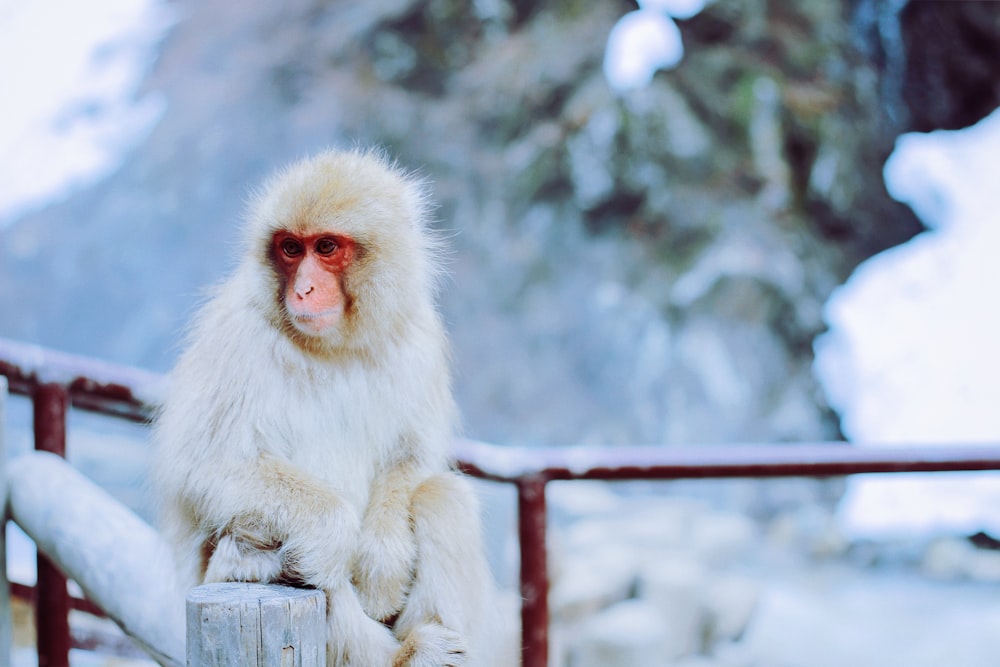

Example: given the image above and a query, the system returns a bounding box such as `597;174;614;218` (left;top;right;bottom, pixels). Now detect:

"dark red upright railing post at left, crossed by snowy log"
32;383;70;667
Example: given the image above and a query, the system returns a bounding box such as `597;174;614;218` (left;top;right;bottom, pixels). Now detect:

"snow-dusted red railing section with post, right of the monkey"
457;441;1000;667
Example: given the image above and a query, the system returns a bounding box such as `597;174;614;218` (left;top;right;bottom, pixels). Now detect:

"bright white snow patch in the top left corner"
0;0;171;227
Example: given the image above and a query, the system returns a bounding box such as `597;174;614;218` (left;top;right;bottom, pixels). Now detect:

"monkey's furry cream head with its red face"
242;151;436;354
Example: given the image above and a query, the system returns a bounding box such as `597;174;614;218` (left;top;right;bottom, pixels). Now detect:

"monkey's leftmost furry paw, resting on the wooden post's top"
205;521;282;584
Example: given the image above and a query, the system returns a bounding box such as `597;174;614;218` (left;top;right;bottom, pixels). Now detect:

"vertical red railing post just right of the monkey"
517;475;549;667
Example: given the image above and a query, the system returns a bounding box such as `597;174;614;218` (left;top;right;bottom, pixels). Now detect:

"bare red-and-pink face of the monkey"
271;231;355;336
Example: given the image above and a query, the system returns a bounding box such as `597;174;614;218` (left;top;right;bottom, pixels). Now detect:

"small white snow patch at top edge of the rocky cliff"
604;0;705;93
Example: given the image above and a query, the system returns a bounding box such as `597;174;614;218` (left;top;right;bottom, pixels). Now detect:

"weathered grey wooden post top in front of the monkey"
187;583;327;667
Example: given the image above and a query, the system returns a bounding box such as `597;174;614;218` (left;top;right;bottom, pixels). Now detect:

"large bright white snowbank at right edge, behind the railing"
815;104;1000;538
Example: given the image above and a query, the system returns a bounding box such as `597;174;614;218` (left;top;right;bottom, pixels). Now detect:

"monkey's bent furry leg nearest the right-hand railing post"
393;473;497;667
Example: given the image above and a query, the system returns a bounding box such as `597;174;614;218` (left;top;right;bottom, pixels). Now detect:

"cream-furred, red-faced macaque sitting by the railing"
154;151;511;667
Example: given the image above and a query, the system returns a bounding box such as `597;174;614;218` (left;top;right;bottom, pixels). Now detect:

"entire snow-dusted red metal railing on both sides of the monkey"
0;339;1000;667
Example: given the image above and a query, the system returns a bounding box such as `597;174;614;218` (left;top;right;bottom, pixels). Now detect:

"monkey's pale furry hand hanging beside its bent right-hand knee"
353;494;417;621
